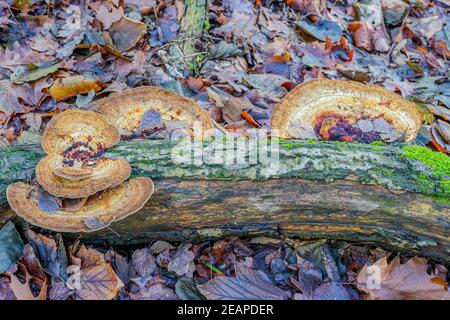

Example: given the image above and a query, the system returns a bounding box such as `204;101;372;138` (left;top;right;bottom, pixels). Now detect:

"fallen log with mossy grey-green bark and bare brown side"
0;140;450;264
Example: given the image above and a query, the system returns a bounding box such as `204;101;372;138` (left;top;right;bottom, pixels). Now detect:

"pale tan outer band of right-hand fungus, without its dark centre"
271;79;422;142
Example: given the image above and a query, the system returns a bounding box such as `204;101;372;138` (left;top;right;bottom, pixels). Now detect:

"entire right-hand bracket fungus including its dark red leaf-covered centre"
271;79;422;143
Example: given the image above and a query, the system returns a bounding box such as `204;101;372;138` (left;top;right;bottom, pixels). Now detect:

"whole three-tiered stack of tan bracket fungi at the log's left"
7;110;153;232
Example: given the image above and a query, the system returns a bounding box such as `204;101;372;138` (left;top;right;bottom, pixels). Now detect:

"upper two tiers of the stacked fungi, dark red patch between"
36;110;131;198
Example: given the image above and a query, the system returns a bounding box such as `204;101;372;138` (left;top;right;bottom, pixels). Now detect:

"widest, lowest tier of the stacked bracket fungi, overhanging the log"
6;177;154;232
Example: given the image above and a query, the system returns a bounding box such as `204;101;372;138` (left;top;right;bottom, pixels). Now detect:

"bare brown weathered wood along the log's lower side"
0;179;450;264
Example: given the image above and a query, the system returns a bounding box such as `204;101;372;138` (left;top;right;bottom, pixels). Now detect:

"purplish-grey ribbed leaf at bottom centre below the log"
198;262;291;300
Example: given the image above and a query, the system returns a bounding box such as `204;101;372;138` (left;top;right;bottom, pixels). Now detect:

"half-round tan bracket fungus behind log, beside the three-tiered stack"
95;86;213;138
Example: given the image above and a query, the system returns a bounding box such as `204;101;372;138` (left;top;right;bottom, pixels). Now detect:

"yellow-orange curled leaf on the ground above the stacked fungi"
50;75;105;100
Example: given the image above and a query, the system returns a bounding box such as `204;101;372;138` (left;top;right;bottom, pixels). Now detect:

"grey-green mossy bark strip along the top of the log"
0;139;450;204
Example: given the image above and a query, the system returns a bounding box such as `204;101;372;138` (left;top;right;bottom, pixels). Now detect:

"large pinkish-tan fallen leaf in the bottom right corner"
357;256;450;300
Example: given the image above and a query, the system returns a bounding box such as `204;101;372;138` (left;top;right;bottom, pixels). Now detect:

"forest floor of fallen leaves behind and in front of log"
0;0;450;300
